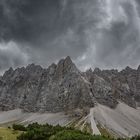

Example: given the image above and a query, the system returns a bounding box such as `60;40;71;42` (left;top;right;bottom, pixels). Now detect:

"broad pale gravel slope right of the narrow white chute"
93;103;140;137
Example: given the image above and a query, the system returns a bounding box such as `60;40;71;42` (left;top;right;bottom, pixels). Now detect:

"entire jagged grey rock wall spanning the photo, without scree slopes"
0;57;140;112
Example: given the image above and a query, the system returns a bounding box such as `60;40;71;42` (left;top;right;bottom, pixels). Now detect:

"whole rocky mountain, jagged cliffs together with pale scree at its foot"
0;57;140;136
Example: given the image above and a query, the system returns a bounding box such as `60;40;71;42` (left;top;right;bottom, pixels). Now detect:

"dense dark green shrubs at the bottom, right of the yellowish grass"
15;123;108;140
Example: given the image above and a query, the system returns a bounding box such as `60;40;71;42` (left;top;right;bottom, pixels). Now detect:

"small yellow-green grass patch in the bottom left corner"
0;128;21;140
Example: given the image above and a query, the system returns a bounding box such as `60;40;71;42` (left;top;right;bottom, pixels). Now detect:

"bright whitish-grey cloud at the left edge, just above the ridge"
0;41;29;73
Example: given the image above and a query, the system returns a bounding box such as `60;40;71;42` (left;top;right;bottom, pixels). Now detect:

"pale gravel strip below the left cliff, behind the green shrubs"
0;109;70;126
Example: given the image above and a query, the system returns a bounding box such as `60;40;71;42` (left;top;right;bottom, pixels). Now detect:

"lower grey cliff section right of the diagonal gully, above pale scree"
86;67;140;108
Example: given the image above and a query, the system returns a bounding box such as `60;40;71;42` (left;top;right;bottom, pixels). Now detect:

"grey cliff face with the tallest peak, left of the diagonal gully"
0;57;94;112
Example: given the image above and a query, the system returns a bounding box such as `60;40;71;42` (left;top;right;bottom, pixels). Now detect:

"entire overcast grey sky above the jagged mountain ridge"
0;0;140;71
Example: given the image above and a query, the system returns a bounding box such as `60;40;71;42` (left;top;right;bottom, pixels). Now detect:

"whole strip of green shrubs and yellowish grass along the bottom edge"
0;123;140;140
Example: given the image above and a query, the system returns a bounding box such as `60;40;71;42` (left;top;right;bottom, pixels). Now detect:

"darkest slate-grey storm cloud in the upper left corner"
1;0;61;42
